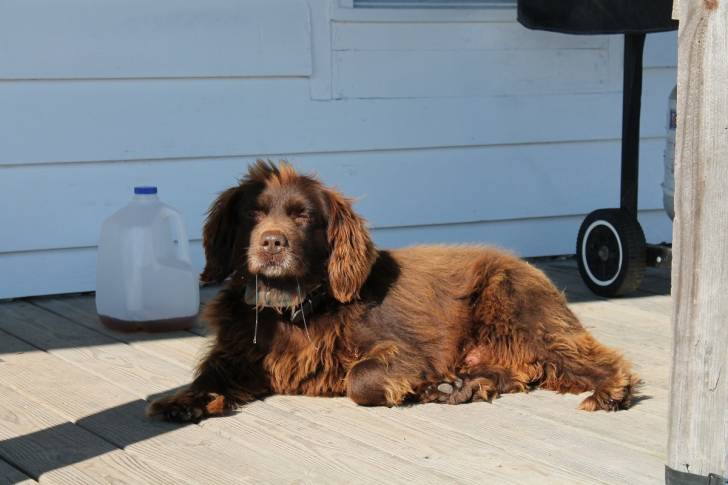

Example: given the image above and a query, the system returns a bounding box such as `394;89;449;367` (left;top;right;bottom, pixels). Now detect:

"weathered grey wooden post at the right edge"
665;0;728;485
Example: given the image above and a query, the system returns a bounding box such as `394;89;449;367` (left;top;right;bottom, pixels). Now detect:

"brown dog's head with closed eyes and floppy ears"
201;161;376;302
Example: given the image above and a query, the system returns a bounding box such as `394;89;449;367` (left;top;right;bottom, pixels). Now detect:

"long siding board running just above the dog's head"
0;74;674;165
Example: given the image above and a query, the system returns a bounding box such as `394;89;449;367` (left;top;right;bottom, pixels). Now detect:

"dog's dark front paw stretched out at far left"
147;390;225;423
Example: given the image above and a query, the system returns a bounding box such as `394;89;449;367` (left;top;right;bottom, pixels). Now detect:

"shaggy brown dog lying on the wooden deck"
148;162;638;421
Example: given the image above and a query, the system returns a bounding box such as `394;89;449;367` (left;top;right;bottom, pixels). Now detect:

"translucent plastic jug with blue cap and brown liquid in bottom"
96;183;200;332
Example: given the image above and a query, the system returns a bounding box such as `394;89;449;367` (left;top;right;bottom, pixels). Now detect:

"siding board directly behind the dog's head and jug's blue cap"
0;139;664;252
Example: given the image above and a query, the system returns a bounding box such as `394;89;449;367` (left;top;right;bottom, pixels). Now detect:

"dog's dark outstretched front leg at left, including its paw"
147;352;267;422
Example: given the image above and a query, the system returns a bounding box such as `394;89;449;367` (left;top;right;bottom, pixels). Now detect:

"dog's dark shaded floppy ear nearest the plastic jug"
200;184;245;283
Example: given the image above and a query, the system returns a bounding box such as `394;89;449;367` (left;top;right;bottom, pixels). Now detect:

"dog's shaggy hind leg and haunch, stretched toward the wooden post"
465;265;639;411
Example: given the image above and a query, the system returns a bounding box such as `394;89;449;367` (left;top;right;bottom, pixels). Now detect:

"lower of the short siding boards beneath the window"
334;49;610;98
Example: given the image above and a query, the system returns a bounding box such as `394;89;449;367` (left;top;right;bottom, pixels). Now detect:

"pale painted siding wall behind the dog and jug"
0;0;675;298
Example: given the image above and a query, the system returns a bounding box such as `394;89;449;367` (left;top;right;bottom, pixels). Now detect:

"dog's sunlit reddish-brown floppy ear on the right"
325;189;377;303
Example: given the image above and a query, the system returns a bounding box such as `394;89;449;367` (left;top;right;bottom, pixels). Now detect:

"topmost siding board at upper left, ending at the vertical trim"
0;0;311;79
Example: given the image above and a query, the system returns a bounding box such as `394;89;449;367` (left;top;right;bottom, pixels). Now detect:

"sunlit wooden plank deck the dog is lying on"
0;260;671;484
